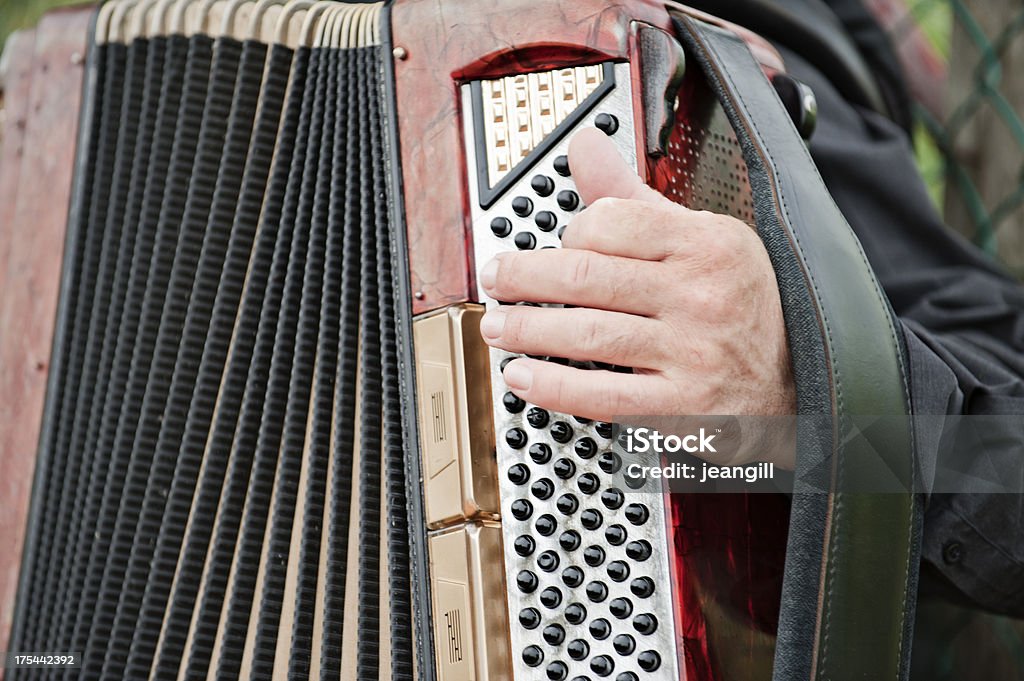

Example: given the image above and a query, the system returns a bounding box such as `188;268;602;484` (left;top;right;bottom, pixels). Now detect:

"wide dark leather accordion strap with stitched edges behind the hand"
676;13;921;681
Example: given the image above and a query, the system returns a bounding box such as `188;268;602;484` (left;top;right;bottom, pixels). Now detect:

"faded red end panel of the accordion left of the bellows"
0;8;92;663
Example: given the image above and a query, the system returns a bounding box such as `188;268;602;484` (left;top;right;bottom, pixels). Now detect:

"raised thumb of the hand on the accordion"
568;128;667;205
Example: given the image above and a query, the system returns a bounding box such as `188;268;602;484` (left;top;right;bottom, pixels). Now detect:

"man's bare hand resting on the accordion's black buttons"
480;129;796;420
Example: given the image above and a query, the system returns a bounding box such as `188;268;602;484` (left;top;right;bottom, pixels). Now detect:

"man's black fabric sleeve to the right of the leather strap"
782;49;1024;615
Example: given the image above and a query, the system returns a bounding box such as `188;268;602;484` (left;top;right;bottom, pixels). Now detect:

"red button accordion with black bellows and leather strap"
8;0;920;681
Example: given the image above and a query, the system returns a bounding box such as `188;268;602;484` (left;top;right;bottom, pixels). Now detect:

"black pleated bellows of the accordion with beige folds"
9;6;413;681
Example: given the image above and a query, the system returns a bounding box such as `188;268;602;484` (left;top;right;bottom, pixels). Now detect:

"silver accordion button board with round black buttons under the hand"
448;62;680;681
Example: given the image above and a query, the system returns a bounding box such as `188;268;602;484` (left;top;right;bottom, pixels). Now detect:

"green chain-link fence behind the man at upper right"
879;0;1024;279
